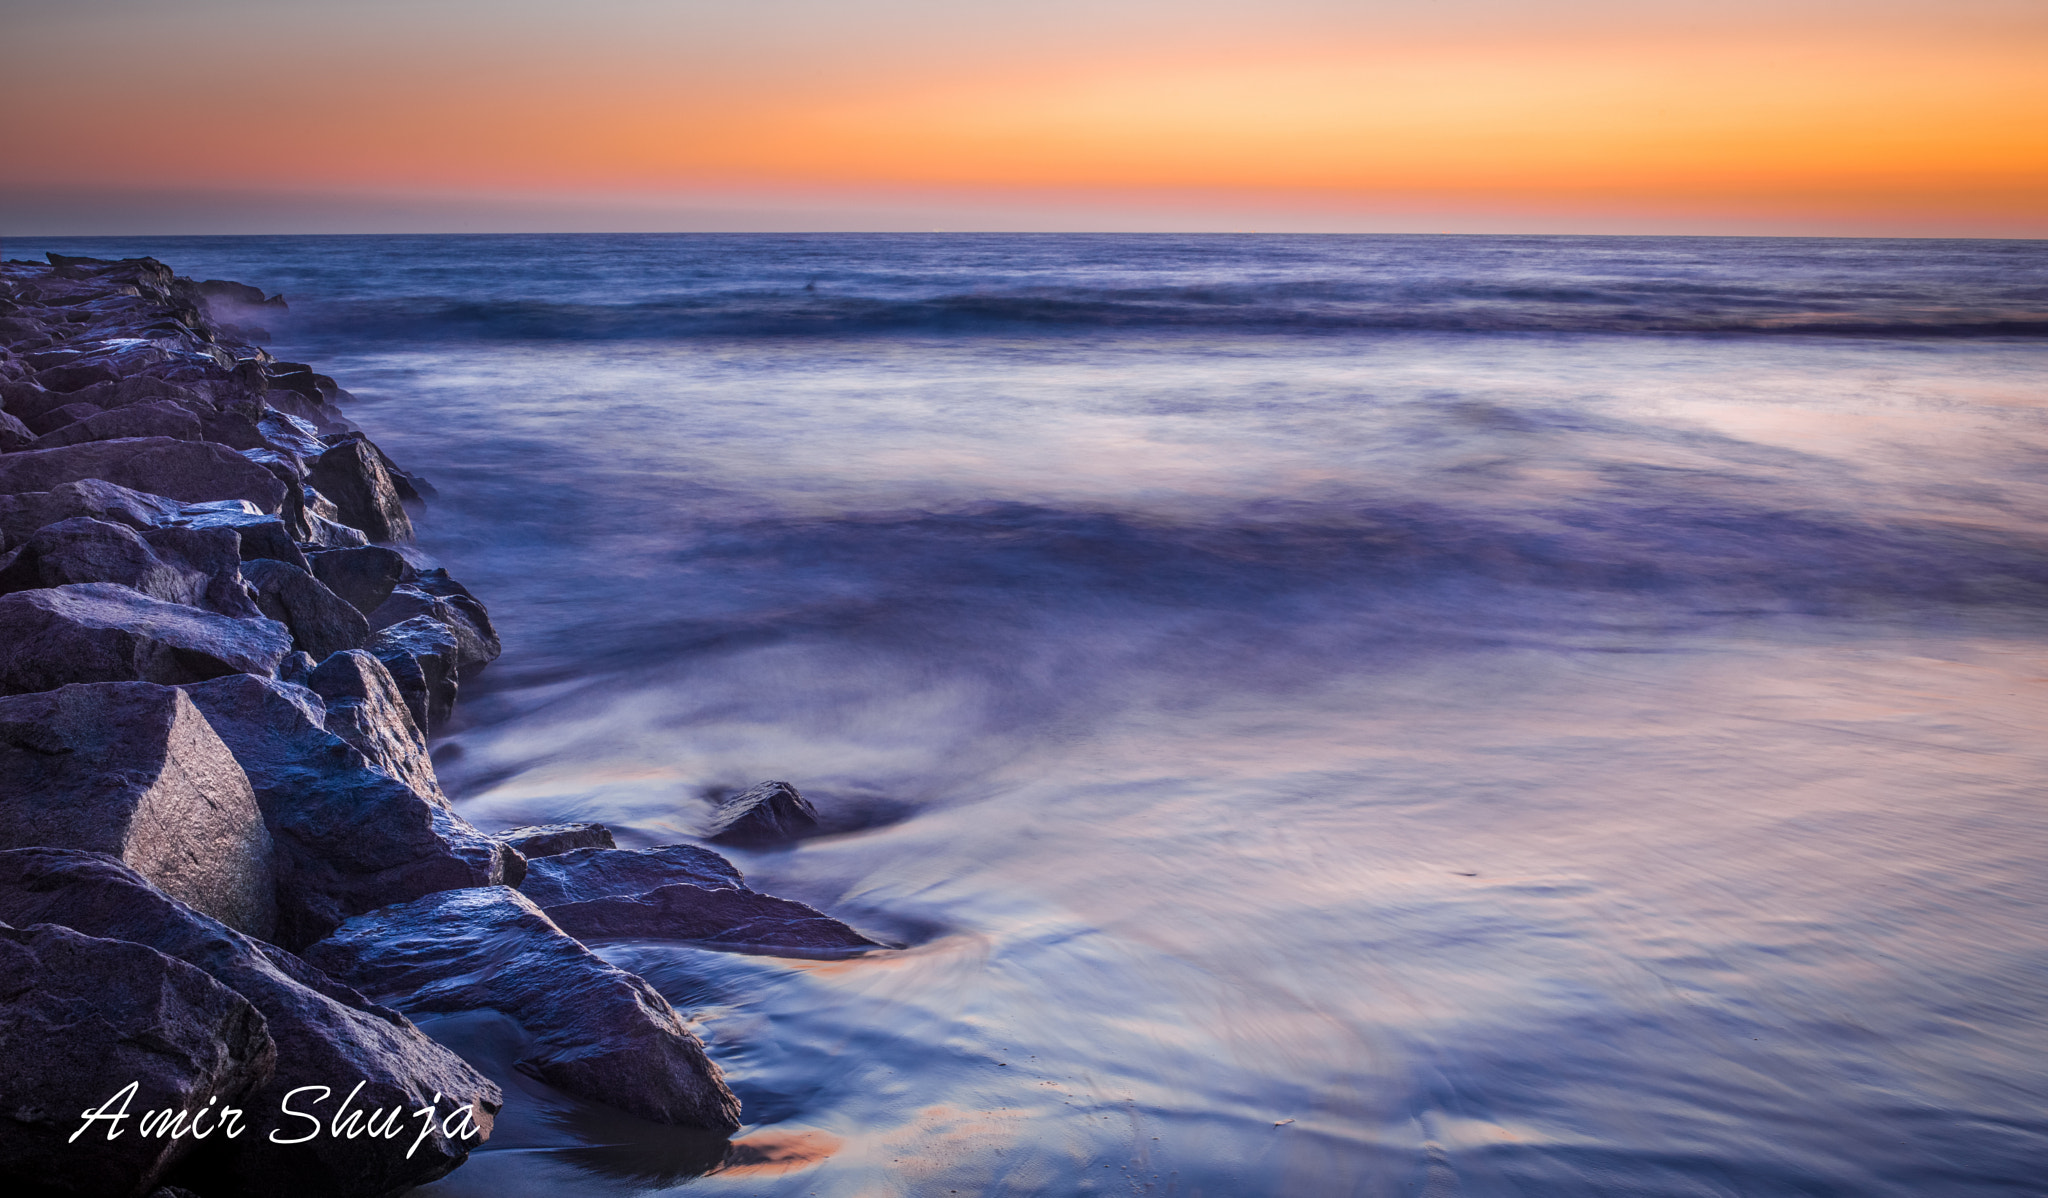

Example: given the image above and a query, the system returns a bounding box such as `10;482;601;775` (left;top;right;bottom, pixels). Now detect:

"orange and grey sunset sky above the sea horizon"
0;0;2048;238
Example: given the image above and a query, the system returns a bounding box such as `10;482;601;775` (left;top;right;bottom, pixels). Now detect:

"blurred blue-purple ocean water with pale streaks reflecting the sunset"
19;233;2048;1198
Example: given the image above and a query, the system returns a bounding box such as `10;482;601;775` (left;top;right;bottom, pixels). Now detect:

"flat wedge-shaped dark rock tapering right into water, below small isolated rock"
520;844;881;956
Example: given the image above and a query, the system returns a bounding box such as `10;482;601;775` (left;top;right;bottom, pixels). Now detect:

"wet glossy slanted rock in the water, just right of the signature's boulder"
307;887;739;1135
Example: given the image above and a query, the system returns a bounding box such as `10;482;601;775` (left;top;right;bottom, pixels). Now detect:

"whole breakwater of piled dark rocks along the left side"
0;254;877;1198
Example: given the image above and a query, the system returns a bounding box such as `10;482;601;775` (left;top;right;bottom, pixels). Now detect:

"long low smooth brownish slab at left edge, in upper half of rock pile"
0;436;285;512
